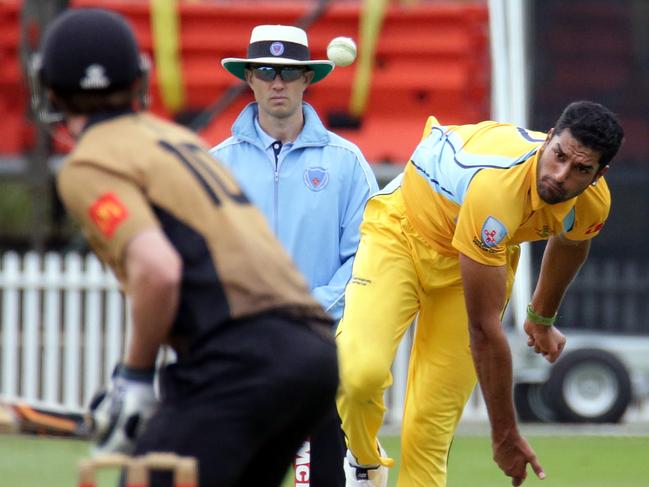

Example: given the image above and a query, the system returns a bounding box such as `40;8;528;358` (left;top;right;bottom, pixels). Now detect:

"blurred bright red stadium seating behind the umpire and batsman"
0;0;490;163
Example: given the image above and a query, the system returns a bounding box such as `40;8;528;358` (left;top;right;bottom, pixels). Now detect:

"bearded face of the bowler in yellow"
536;129;608;204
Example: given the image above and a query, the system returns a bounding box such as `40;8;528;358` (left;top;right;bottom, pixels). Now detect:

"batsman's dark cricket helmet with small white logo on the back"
30;8;148;122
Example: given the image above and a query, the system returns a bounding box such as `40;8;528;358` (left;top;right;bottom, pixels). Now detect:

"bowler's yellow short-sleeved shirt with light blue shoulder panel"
401;117;611;266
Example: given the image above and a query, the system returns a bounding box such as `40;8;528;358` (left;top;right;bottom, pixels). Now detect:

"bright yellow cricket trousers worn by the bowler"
336;188;513;487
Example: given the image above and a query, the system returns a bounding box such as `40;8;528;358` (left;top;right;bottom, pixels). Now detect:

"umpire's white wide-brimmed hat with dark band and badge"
221;25;334;84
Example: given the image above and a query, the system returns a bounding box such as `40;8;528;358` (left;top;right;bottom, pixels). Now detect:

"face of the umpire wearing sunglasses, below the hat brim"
246;65;313;119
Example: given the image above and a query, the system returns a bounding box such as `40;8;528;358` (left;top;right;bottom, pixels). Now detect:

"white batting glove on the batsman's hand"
90;365;158;455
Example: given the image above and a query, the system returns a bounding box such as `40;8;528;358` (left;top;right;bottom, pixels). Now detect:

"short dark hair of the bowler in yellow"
554;101;624;169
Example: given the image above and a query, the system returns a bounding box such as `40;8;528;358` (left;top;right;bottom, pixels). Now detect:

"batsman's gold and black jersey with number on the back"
58;112;329;346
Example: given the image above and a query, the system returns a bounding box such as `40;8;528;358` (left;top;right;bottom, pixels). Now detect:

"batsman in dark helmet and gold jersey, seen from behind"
33;8;338;487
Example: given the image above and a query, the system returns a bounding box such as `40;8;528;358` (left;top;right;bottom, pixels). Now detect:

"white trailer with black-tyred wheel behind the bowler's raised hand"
510;331;649;423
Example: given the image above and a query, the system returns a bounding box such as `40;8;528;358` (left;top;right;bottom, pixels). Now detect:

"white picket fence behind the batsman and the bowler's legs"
0;252;486;424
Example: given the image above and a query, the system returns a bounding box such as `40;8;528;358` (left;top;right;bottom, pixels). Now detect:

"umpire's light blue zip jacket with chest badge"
210;103;378;320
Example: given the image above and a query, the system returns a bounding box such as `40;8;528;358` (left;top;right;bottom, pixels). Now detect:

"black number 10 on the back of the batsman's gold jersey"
158;140;250;206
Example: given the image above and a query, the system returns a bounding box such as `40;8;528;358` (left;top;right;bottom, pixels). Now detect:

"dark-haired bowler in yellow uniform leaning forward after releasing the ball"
336;101;624;487
